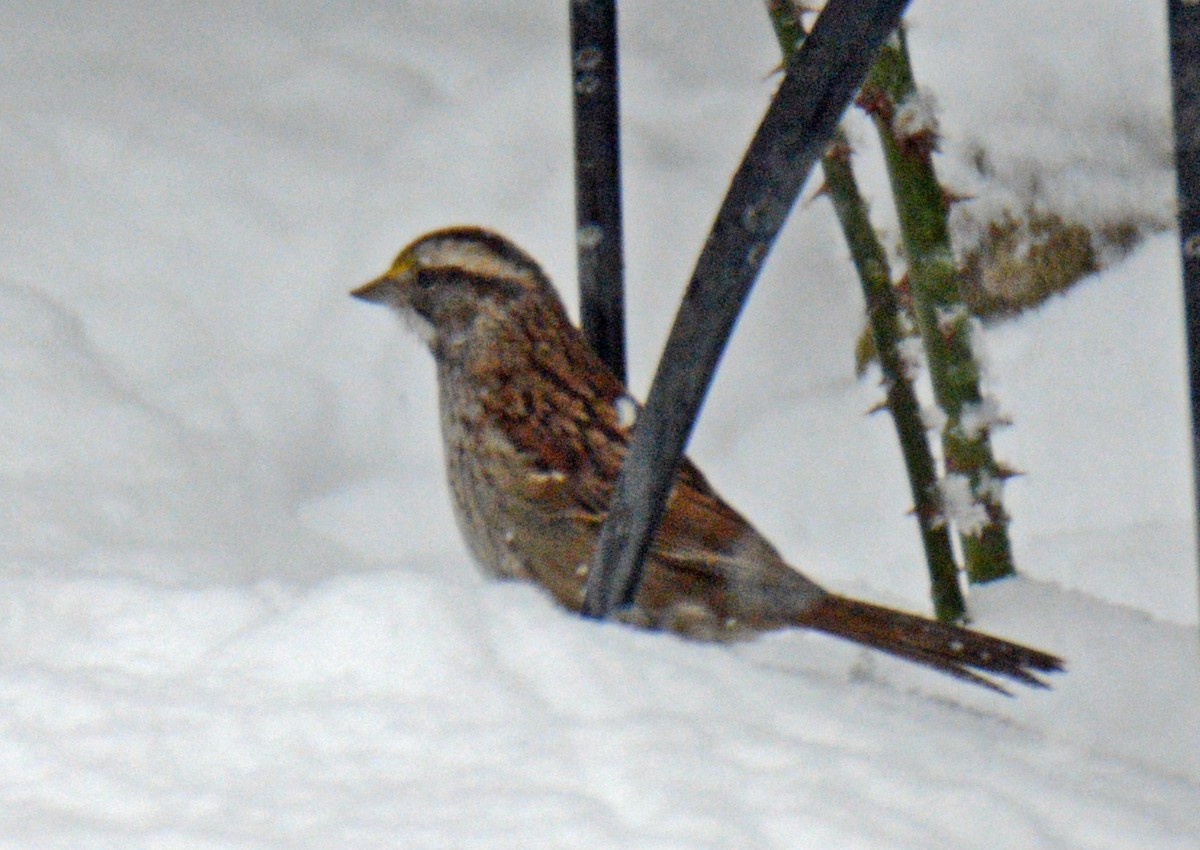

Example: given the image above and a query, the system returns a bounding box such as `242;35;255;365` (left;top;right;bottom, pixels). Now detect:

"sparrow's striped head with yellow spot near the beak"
350;227;562;353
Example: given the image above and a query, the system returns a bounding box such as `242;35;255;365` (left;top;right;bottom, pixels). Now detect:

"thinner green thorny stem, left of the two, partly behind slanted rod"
767;0;966;622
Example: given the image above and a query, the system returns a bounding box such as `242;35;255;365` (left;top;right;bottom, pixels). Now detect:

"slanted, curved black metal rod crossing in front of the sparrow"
583;0;908;617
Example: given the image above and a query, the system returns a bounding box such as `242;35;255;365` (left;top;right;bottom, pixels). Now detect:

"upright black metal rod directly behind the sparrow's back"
571;0;625;382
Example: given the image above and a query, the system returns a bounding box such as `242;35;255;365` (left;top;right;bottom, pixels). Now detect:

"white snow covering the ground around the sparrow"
0;0;1200;850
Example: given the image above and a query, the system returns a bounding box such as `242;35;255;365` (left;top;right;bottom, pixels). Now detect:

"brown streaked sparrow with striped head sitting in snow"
353;227;1062;689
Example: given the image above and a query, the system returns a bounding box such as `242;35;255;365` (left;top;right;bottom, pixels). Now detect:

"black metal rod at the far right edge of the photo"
1166;0;1200;619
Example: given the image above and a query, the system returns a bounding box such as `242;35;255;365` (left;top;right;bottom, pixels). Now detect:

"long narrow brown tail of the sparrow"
796;594;1063;695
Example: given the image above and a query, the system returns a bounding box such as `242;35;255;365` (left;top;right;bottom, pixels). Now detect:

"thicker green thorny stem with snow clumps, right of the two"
859;29;1015;582
